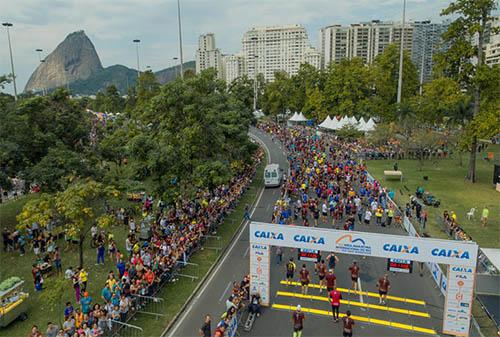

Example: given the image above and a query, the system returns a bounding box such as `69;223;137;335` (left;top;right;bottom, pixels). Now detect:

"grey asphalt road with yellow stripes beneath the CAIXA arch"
166;129;444;337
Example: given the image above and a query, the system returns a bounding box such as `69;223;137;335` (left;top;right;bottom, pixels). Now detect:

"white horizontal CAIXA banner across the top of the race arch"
250;222;478;268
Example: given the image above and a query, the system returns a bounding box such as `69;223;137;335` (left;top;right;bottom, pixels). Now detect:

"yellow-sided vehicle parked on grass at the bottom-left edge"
0;278;29;328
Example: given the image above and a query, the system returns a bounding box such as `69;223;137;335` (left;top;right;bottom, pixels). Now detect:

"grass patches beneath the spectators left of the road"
0;156;265;337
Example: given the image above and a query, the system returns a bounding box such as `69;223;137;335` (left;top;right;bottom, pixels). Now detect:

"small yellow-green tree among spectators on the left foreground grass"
17;180;119;267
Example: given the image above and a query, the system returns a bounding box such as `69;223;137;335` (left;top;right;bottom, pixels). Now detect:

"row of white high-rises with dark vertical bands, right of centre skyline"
319;20;413;67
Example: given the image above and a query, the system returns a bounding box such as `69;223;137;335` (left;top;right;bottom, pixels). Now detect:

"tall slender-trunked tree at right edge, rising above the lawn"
437;0;498;182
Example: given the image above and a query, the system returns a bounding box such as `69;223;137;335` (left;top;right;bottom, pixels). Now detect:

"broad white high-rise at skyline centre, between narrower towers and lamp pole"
242;25;316;81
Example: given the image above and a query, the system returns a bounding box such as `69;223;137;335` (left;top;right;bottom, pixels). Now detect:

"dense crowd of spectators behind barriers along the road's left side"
8;149;263;337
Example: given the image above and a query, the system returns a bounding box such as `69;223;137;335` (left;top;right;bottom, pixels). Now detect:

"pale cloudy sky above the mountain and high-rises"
0;0;450;93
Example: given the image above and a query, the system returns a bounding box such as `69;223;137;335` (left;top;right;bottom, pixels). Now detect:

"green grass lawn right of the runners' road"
367;145;500;248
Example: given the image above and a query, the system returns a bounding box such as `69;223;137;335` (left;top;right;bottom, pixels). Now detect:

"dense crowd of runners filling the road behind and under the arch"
259;123;406;337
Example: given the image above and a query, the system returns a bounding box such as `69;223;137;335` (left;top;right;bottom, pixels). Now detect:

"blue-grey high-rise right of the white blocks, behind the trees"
411;21;448;83
